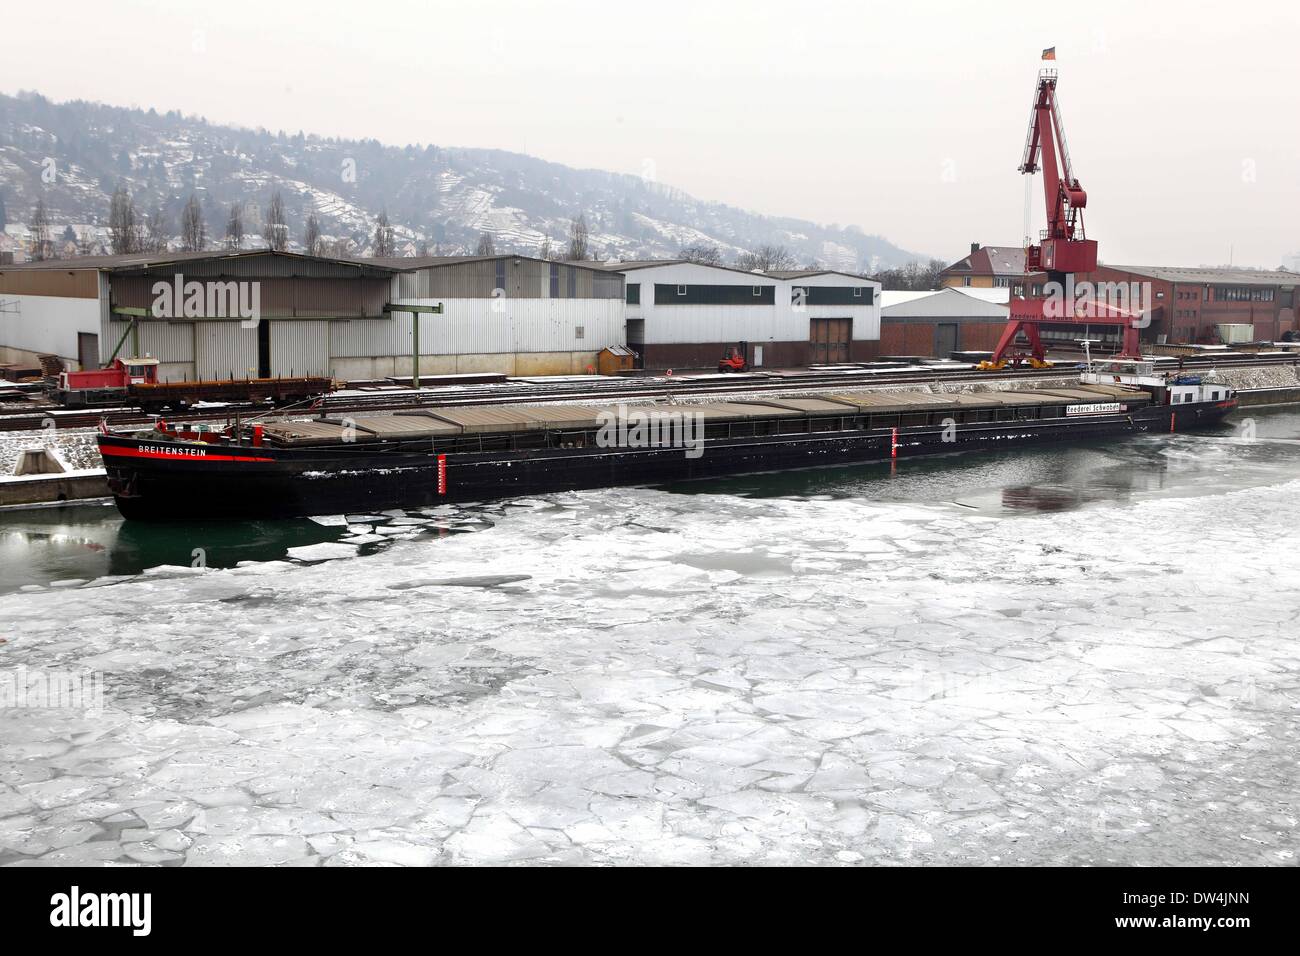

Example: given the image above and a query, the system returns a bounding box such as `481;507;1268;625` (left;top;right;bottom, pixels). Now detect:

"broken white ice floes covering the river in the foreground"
0;483;1300;865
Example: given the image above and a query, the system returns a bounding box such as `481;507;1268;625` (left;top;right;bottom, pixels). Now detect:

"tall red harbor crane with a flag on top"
982;56;1140;368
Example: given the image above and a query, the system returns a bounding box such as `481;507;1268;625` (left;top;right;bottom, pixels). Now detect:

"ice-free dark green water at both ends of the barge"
0;407;1300;593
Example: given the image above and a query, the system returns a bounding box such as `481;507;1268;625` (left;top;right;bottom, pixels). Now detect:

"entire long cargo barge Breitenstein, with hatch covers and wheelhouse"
99;360;1236;520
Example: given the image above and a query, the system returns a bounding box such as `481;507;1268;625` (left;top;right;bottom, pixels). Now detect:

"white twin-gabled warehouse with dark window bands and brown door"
603;259;880;369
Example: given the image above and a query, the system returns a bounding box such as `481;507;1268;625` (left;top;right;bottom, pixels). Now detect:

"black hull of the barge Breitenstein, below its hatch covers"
99;401;1236;520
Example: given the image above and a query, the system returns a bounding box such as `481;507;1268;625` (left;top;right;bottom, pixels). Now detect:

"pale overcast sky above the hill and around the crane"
0;0;1300;268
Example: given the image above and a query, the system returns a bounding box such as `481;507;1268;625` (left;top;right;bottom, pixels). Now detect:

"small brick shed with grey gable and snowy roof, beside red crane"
880;287;1011;359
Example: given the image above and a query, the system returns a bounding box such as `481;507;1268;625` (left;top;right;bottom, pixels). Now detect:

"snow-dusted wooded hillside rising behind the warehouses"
0;94;917;272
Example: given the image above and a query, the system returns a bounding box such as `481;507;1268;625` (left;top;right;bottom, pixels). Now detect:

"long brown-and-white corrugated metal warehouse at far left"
0;250;624;381
